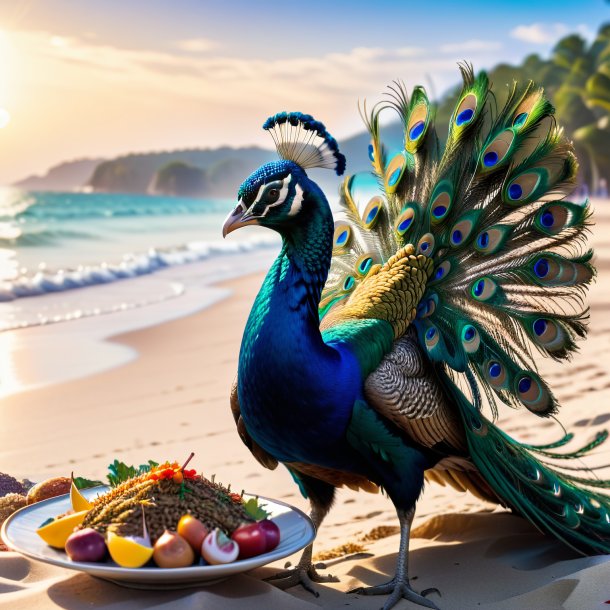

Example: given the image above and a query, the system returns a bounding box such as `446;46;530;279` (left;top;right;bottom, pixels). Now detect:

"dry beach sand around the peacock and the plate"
0;202;610;610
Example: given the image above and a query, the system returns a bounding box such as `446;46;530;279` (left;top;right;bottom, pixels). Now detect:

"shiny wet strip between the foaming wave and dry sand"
0;248;275;398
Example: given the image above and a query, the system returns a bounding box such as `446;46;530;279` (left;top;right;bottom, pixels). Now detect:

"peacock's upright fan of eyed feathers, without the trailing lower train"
320;66;594;416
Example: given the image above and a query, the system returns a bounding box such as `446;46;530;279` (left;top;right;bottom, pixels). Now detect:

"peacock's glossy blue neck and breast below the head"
238;185;361;461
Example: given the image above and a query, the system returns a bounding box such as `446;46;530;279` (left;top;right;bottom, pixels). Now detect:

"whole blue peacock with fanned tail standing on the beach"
223;64;610;610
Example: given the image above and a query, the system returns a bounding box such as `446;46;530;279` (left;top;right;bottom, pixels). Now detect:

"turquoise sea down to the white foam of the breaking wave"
0;190;276;300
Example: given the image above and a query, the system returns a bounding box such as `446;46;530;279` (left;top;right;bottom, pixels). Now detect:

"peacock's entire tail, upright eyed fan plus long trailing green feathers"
320;66;610;553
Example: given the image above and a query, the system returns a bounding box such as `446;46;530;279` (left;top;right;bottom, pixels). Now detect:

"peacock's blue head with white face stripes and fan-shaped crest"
222;112;345;237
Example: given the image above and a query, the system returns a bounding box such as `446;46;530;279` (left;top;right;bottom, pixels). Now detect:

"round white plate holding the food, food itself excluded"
2;487;315;589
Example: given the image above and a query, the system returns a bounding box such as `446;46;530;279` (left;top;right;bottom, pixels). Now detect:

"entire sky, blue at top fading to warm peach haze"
0;0;610;184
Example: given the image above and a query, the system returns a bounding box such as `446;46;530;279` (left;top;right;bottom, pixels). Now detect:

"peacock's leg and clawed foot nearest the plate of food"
265;475;339;597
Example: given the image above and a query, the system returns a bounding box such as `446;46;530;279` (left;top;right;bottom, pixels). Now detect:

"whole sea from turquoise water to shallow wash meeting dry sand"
0;189;279;396
